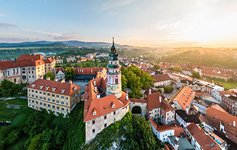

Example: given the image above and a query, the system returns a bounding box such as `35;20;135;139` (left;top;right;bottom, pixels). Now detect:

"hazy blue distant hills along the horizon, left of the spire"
0;41;130;48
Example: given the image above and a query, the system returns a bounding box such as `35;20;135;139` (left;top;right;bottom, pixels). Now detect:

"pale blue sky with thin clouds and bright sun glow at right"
0;0;237;47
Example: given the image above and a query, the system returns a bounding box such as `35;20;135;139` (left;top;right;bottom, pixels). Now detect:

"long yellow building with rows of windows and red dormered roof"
27;79;80;117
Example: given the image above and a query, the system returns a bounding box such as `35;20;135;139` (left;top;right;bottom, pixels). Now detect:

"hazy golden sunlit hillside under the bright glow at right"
160;48;237;69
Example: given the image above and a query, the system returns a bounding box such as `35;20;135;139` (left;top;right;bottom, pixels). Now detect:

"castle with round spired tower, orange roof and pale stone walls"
83;40;130;143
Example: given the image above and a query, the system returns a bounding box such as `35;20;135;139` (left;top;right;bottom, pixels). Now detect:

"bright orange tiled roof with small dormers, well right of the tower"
173;86;195;111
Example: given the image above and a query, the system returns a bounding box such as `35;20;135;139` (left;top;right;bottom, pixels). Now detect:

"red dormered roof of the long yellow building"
28;79;80;96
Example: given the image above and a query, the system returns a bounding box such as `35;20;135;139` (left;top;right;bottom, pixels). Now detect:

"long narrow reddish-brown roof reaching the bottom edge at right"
187;122;220;150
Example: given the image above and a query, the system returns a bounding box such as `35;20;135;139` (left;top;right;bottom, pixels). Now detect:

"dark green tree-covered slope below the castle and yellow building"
0;100;162;150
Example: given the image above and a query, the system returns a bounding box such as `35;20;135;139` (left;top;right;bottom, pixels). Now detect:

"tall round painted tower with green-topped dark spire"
106;38;122;98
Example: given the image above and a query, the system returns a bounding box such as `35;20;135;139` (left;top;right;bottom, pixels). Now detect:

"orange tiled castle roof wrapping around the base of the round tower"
84;78;130;122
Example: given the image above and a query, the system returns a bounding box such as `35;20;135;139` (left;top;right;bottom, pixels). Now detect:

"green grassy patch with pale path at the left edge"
0;99;27;121
